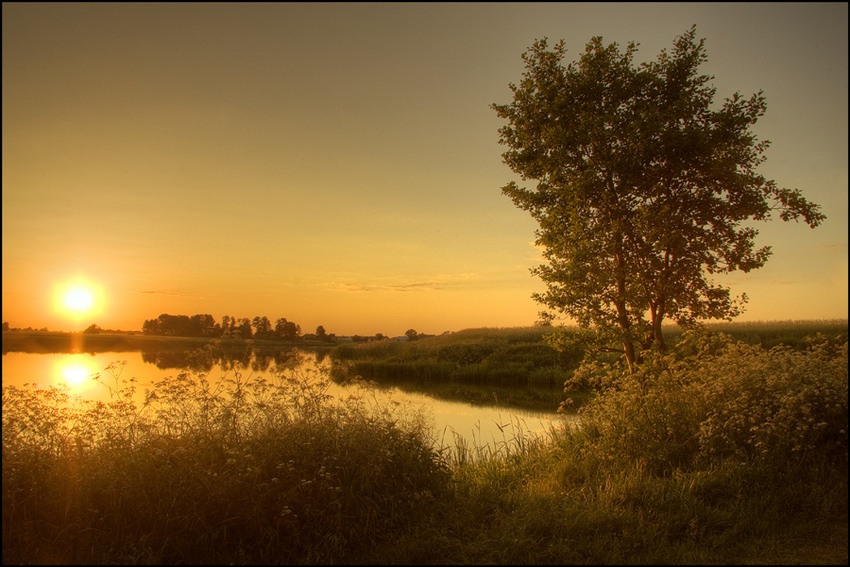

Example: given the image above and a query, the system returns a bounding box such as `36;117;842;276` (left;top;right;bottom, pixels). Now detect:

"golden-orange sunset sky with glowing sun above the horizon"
2;2;848;336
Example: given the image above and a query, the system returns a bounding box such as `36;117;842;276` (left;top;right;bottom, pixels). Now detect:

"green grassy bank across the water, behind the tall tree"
331;320;847;394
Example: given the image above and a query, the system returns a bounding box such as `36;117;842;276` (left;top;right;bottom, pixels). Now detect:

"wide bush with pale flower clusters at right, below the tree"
574;335;848;475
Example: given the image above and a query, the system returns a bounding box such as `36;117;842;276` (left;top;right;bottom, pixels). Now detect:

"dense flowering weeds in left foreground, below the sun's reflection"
3;352;448;564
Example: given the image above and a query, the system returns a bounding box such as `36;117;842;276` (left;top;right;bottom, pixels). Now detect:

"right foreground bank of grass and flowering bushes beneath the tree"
386;336;848;564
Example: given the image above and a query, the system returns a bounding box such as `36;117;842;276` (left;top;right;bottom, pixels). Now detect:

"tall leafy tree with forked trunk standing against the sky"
492;26;825;371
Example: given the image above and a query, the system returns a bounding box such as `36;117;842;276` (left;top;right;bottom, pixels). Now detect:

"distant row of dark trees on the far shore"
142;313;316;340
